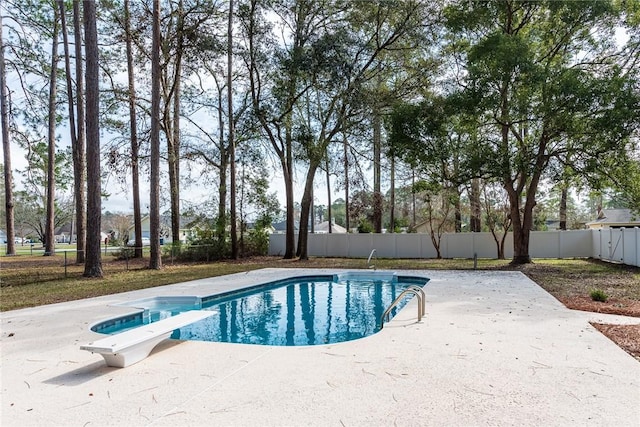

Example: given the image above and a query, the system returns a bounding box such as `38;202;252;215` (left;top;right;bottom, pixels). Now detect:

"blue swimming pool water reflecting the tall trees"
92;272;429;346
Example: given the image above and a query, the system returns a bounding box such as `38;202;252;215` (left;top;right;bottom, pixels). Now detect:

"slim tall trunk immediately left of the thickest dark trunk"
71;1;87;264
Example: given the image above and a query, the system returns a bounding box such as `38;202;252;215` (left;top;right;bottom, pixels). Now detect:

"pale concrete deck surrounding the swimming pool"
0;269;640;426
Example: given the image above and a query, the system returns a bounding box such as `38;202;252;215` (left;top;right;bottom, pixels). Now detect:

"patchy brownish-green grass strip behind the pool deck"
0;251;640;311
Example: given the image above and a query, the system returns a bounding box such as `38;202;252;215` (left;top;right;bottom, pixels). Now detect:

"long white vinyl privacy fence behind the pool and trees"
269;227;640;266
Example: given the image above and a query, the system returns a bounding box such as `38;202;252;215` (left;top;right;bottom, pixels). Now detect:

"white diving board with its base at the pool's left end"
80;310;216;368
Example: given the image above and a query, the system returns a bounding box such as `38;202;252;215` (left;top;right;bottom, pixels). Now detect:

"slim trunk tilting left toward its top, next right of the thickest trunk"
124;0;143;258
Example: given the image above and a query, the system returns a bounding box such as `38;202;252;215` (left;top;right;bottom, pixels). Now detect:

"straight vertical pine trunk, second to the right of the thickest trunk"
149;0;162;270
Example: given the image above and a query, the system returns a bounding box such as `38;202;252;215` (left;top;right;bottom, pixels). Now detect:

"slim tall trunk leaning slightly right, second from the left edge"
44;9;59;256
